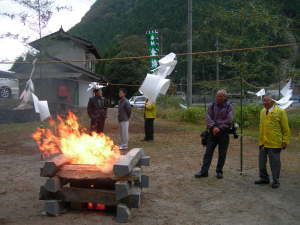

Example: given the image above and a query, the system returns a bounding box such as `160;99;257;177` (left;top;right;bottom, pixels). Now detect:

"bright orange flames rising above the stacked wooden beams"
32;112;120;173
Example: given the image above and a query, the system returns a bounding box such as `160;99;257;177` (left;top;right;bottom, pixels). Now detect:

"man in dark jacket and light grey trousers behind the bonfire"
118;89;131;150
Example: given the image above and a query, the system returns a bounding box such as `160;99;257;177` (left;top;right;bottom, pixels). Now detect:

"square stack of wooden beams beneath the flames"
40;148;150;223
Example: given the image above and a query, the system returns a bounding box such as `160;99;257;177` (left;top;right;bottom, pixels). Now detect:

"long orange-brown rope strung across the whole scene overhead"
0;42;300;64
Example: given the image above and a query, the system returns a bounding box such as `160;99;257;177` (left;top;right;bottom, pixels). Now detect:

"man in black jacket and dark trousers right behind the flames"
87;89;107;133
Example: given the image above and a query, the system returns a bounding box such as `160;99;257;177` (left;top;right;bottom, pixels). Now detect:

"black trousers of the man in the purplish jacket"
201;132;229;174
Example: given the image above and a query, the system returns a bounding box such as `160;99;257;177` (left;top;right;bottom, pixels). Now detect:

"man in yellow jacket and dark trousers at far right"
255;94;290;188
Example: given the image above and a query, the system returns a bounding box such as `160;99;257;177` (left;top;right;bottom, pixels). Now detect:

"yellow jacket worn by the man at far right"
259;105;291;148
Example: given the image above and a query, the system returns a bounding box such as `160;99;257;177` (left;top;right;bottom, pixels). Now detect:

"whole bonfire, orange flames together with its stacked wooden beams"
33;113;150;222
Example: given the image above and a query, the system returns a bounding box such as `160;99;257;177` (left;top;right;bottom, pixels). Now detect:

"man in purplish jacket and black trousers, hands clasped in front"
195;90;233;179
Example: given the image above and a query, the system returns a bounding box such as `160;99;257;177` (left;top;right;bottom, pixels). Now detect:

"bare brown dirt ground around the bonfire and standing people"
0;108;300;225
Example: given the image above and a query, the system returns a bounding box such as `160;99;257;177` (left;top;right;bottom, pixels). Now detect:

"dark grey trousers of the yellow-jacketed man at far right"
259;148;281;182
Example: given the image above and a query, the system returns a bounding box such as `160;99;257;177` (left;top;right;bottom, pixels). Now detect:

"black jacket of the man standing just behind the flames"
87;96;108;120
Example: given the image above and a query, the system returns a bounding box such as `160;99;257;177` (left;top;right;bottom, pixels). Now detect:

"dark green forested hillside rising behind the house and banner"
71;0;300;89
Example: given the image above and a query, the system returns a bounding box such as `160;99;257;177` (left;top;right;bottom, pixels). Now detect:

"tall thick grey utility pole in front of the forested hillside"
187;0;193;106
